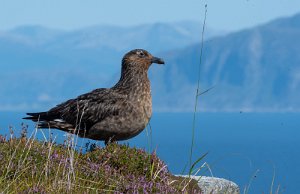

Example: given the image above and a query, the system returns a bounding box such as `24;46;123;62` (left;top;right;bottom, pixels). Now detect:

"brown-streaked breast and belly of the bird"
89;77;152;140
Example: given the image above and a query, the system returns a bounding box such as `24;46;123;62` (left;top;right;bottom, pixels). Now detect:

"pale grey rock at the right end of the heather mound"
179;175;240;194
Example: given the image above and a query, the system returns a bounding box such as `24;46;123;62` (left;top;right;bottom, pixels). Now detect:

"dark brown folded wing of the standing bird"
48;88;126;128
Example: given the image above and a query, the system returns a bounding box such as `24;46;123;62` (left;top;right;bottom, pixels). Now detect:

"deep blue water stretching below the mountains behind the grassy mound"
0;112;300;194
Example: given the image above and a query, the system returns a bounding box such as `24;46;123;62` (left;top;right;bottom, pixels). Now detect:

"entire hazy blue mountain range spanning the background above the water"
0;14;300;111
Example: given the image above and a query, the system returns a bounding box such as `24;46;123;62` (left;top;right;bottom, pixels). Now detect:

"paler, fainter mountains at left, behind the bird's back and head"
0;21;218;111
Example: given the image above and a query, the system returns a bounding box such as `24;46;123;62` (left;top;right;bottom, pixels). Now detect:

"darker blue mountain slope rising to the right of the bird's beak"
153;14;300;111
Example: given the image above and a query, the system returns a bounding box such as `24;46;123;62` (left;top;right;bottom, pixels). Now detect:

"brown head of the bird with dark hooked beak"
122;49;165;70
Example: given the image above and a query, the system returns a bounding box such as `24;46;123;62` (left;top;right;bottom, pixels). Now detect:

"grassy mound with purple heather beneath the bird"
0;128;201;193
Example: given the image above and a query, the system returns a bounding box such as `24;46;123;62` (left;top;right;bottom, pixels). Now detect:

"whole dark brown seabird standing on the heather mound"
23;49;165;145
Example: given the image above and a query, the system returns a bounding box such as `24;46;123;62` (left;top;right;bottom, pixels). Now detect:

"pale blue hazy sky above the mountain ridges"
0;0;300;30
